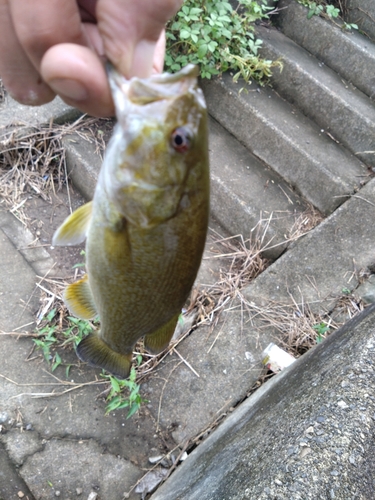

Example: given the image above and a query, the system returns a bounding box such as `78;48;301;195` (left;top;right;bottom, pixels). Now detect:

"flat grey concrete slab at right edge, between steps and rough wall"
243;179;375;311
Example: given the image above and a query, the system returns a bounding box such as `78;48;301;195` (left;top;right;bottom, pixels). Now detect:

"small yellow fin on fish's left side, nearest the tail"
63;274;97;319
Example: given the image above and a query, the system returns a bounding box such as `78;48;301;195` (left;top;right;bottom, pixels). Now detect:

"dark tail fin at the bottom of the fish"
77;333;132;379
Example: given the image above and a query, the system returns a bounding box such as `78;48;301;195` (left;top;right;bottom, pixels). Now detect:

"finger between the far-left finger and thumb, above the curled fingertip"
9;0;88;70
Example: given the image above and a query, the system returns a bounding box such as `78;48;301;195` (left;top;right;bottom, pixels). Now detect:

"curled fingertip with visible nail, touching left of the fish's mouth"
41;43;114;116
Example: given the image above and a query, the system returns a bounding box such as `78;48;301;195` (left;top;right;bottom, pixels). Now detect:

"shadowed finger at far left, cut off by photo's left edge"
0;0;55;105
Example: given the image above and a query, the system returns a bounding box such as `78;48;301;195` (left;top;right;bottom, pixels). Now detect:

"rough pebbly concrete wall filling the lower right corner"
152;306;375;500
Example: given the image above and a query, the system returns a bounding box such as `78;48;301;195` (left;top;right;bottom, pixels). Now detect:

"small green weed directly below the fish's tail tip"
103;355;148;418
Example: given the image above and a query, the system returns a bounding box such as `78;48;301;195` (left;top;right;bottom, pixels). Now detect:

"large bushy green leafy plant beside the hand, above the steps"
165;0;282;84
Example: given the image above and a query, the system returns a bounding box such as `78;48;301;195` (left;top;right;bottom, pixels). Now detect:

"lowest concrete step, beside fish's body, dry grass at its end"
210;119;308;260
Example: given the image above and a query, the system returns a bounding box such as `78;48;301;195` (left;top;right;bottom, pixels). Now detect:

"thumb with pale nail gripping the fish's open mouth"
96;0;182;78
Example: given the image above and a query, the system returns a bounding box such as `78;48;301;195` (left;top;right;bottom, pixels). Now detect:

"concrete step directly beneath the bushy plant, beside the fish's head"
202;75;368;214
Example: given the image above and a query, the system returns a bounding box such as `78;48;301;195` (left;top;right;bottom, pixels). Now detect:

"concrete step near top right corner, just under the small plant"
272;0;375;98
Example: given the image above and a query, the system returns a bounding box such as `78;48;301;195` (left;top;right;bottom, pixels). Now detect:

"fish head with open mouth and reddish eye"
103;65;208;228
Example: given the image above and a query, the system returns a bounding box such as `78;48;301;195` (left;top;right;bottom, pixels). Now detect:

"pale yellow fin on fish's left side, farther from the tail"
52;201;92;246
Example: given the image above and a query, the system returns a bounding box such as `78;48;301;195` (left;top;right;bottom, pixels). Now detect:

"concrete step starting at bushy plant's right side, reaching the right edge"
257;26;375;166
